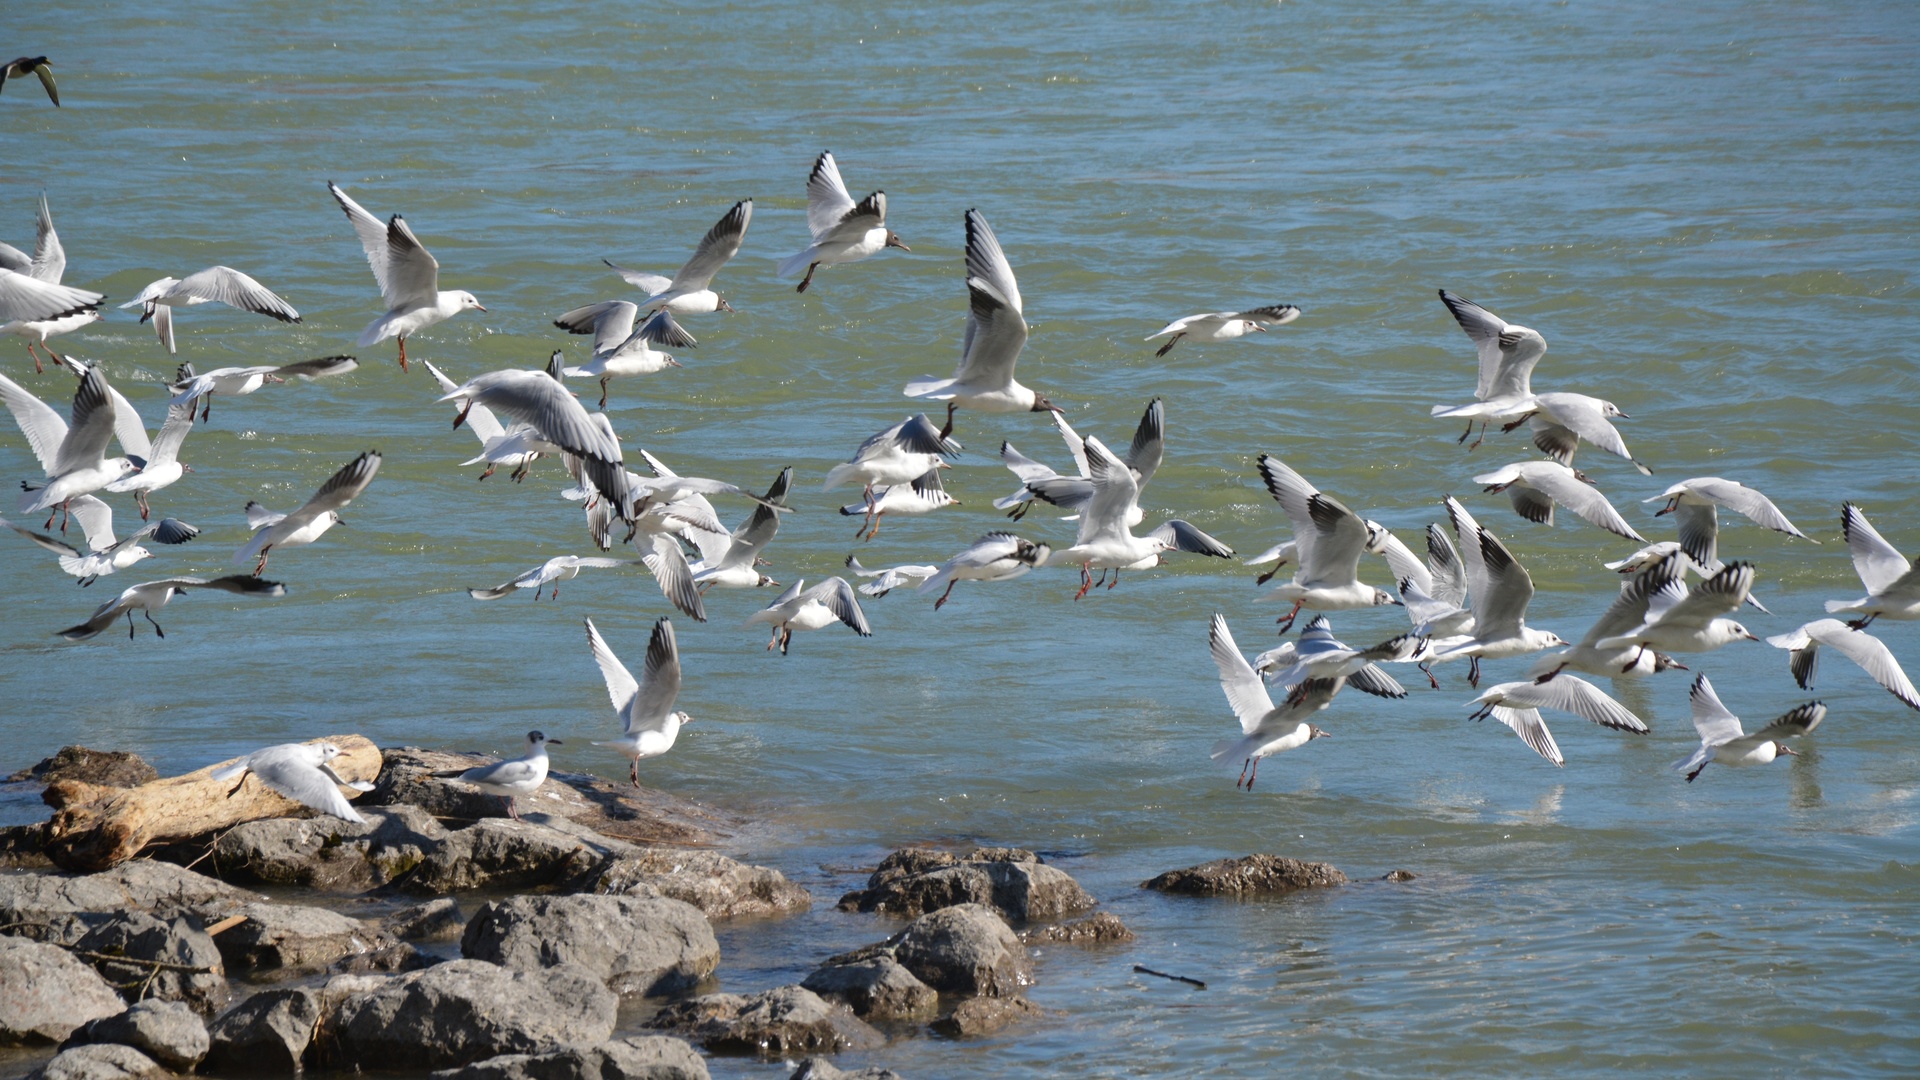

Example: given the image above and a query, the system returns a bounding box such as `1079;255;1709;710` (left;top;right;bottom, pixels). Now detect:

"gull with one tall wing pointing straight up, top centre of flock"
900;209;1058;413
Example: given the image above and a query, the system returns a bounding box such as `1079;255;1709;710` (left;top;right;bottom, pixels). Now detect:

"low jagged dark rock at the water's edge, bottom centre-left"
649;986;887;1057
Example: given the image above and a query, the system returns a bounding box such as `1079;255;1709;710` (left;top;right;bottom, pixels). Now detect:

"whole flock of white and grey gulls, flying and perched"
0;138;1920;819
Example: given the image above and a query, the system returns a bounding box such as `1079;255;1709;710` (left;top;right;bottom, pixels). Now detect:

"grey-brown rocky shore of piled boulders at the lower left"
0;748;1346;1080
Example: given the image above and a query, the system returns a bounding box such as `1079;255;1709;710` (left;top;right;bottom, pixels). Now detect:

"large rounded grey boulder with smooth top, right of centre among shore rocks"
461;896;720;994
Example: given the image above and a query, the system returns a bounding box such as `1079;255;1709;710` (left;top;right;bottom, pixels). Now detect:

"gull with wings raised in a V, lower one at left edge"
0;367;146;532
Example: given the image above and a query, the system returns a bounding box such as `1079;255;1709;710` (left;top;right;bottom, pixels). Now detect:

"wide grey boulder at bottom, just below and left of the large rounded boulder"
317;942;620;1072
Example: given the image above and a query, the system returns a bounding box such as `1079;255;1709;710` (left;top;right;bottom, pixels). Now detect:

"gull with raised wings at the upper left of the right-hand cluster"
1260;454;1400;634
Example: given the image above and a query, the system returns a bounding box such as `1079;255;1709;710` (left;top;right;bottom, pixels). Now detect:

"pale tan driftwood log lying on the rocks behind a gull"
40;734;380;872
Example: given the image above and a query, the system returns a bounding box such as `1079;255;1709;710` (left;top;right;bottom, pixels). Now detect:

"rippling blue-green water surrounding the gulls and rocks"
0;2;1920;1078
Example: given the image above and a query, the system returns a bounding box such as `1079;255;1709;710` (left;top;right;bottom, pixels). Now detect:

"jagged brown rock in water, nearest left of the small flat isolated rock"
839;847;1094;919
